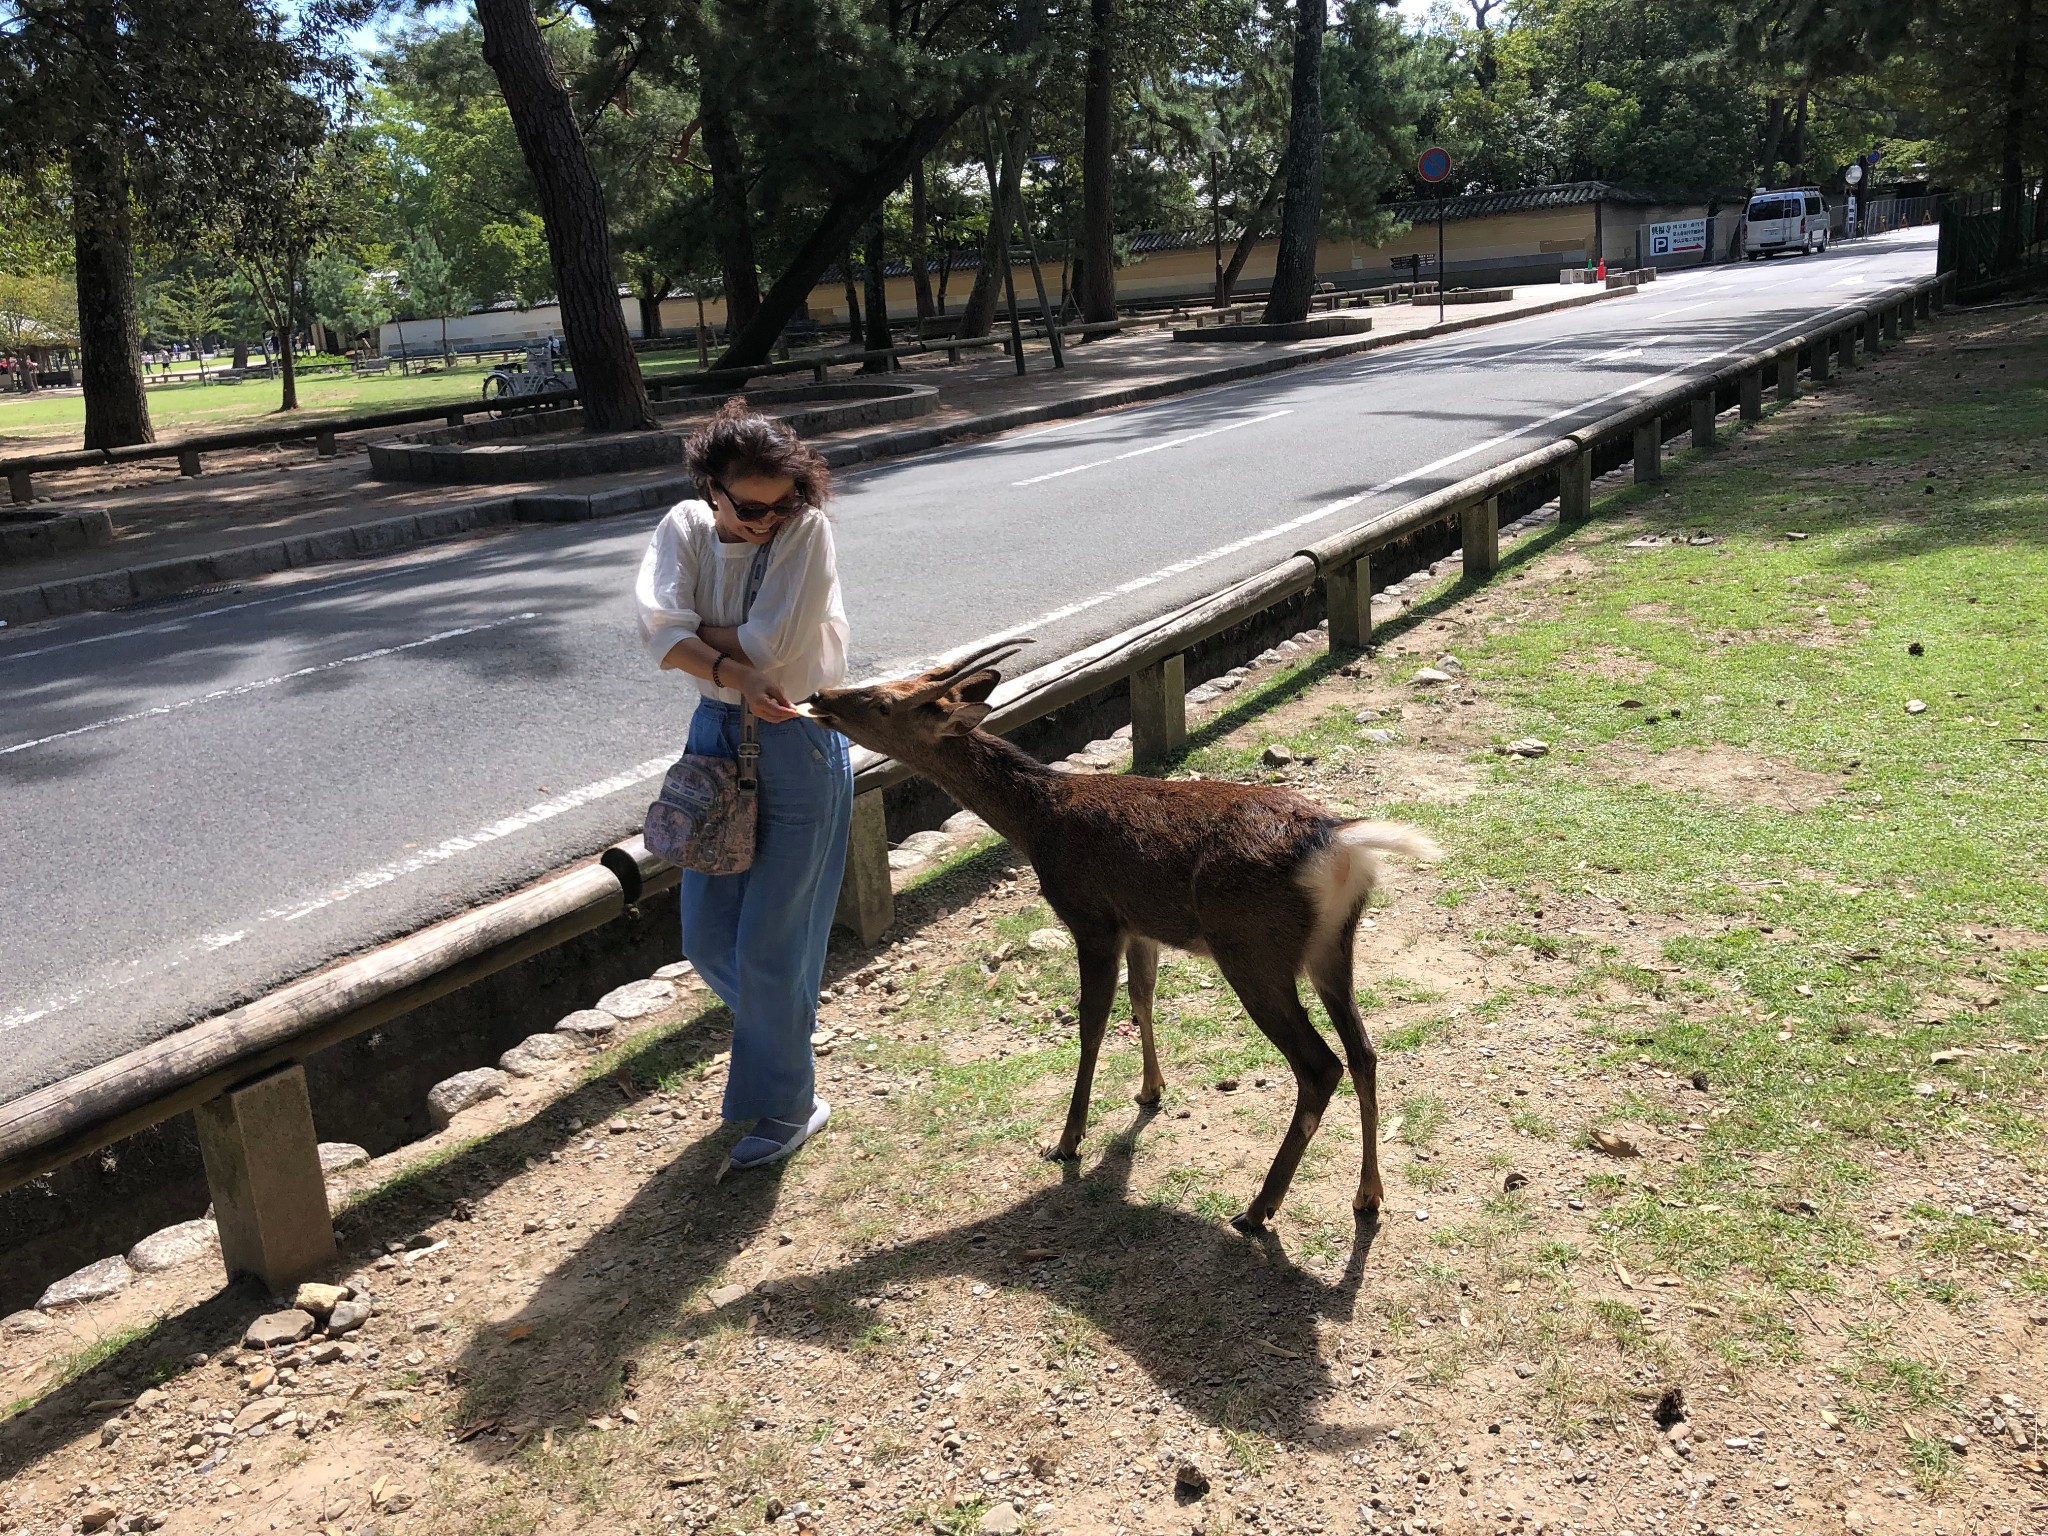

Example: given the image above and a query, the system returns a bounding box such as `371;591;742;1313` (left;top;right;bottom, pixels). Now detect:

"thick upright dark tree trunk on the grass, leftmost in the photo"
72;141;156;449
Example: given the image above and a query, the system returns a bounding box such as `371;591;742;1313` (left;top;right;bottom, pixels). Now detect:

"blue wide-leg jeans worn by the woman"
682;698;854;1122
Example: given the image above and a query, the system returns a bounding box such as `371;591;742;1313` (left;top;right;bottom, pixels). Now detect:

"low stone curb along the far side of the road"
0;287;1634;625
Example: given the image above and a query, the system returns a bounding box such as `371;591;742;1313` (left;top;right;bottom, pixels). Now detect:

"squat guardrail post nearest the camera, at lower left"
193;1063;334;1292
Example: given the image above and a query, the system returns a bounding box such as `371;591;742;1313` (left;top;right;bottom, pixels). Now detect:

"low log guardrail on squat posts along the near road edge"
0;274;1952;1288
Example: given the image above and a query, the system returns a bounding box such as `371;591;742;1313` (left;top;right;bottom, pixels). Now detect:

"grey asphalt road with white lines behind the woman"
0;231;1933;1102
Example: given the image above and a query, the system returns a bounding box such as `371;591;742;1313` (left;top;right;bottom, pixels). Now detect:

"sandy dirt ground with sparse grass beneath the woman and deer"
0;301;2048;1536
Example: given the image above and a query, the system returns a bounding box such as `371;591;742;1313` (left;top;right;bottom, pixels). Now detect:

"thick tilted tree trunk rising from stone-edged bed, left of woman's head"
475;0;653;432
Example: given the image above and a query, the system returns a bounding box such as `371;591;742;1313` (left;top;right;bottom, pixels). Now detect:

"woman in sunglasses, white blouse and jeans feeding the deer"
635;399;854;1176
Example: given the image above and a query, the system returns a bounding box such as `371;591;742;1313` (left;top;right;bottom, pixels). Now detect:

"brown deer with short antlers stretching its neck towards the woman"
807;641;1438;1233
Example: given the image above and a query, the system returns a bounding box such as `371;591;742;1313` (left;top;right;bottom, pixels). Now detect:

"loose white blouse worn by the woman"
633;502;848;705
